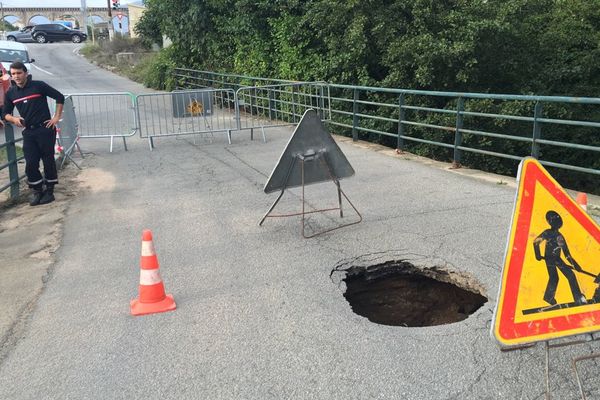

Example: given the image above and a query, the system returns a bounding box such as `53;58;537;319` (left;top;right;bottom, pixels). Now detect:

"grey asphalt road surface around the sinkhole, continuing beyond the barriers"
0;44;600;400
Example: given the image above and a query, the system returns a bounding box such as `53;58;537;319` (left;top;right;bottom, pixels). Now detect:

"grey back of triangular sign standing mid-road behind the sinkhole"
264;109;354;193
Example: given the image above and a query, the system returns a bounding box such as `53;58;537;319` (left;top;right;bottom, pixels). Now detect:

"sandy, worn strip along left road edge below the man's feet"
0;160;82;368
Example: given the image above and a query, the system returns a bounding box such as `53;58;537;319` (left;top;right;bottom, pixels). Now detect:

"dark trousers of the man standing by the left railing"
23;126;58;191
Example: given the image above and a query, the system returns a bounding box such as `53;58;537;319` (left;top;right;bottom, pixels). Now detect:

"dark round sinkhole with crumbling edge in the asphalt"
343;261;487;327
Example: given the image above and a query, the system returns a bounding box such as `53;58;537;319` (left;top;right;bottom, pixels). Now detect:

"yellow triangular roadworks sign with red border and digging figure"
492;158;600;346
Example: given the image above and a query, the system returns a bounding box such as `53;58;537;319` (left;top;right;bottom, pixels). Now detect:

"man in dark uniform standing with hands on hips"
2;61;65;206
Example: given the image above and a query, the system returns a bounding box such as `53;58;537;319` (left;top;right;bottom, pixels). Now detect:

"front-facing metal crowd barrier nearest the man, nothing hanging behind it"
69;92;138;152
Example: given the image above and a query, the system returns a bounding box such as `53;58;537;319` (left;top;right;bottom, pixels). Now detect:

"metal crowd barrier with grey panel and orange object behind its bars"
136;89;239;149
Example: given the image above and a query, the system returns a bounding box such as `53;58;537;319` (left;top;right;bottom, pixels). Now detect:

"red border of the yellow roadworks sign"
492;158;600;345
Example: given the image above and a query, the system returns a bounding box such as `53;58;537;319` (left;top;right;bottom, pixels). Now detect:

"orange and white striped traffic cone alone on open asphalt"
130;229;177;315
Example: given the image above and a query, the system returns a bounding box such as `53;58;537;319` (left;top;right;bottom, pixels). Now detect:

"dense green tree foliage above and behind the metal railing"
139;0;600;191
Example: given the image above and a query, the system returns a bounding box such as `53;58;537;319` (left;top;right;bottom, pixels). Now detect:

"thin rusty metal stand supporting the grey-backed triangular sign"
258;150;362;239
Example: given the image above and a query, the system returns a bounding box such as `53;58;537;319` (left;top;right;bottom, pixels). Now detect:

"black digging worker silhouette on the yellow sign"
533;210;587;307
